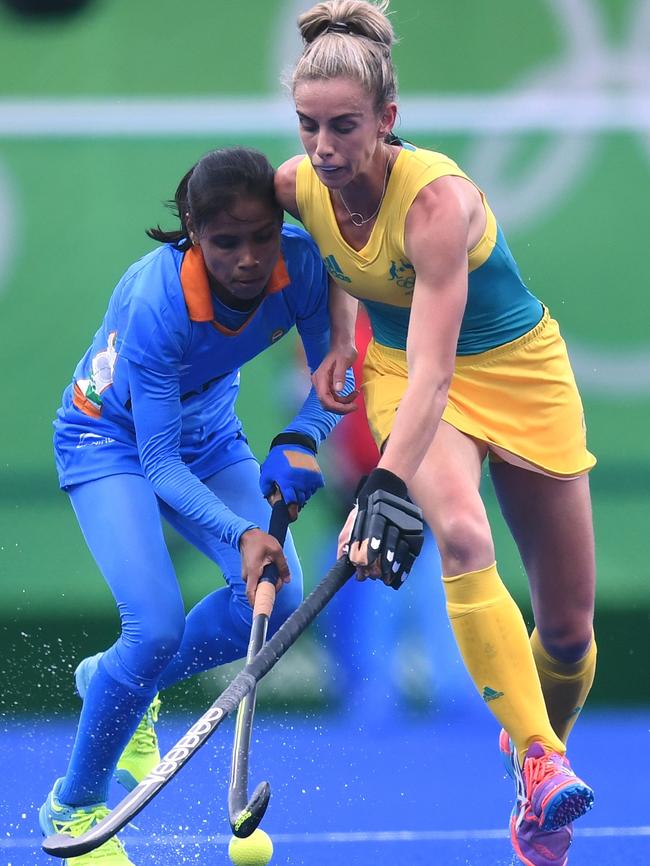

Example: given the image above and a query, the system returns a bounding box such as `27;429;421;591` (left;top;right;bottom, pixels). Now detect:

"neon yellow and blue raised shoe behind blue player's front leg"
75;653;160;791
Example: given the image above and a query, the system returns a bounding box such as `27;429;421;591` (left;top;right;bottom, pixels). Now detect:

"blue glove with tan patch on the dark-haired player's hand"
260;433;325;508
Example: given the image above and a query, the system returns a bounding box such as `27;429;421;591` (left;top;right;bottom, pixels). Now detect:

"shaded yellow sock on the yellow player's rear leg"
530;629;596;744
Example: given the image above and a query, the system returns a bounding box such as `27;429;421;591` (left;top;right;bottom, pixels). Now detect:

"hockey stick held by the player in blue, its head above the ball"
228;493;289;839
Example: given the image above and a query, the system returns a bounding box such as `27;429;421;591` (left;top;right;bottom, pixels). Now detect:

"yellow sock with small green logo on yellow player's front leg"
442;563;565;758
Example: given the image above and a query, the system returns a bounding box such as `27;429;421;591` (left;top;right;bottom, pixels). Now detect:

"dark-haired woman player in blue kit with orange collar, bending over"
40;148;351;866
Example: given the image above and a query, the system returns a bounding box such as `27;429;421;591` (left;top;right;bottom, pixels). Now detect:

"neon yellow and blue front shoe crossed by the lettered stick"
38;779;135;866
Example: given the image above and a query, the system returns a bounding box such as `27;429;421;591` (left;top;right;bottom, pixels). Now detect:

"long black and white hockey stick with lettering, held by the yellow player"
43;556;355;857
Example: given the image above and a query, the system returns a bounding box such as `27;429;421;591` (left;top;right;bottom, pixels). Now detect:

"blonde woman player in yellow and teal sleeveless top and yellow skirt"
276;0;596;866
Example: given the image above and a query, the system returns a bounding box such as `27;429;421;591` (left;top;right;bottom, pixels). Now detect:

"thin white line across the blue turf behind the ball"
6;826;650;849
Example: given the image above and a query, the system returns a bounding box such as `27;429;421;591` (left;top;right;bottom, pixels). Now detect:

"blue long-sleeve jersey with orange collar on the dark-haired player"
54;225;353;546
